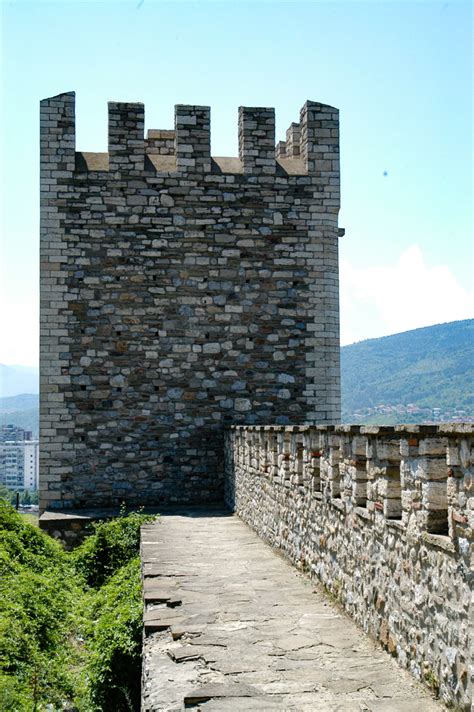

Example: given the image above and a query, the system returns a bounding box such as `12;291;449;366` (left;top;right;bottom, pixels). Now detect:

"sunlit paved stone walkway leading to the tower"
142;510;445;712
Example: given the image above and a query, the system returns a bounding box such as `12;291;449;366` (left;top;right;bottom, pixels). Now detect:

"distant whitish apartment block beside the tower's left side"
0;426;39;490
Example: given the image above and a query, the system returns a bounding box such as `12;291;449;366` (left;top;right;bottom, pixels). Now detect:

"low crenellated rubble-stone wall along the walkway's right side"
226;424;474;710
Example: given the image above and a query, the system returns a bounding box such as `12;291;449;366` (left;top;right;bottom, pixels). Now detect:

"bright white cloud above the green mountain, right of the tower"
340;245;474;344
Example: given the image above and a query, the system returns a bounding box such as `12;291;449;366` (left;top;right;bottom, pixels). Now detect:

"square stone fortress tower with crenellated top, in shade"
40;93;343;509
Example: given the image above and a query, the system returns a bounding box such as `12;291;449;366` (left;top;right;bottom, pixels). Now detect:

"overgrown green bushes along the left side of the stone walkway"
0;499;157;712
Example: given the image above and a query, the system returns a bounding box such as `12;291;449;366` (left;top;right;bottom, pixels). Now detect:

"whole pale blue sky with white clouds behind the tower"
0;0;474;365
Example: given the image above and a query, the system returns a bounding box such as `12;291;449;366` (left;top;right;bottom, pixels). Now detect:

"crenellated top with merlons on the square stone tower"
41;92;339;178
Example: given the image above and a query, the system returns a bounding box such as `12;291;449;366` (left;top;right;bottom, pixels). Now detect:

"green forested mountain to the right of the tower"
341;319;474;425
